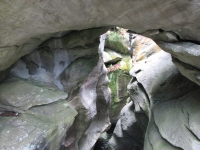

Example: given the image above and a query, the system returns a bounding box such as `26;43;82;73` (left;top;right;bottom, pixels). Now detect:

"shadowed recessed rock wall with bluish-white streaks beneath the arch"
10;28;107;92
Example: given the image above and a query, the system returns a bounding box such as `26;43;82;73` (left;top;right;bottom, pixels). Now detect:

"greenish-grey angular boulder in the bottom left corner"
0;100;77;150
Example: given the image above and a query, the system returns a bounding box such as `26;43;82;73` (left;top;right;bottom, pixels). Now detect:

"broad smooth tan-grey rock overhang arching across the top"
0;0;200;71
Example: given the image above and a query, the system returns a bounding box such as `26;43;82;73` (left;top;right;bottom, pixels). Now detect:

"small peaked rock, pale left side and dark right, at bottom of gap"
108;102;148;150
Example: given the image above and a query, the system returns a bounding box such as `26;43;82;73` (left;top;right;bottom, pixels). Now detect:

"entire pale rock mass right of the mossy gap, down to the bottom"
109;51;200;150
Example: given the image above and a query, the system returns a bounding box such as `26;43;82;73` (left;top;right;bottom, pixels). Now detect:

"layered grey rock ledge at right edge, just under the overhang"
158;42;200;85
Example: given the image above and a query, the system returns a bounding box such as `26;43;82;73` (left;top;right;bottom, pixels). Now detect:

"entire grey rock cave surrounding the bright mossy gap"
0;0;200;150
